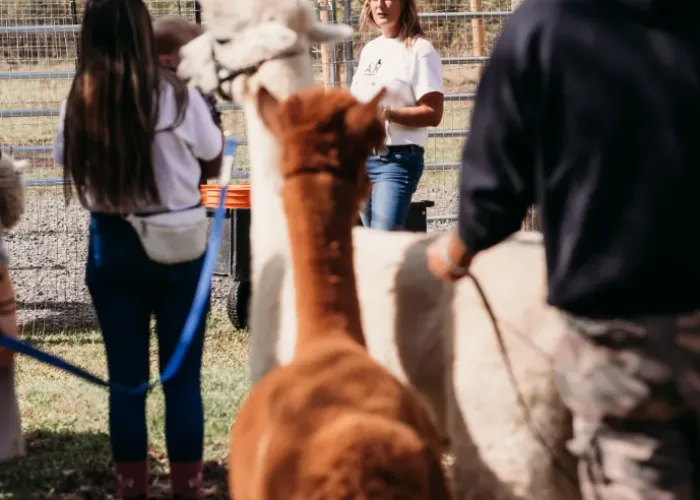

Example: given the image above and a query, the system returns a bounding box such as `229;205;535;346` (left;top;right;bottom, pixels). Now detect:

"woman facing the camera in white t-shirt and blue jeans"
351;0;444;231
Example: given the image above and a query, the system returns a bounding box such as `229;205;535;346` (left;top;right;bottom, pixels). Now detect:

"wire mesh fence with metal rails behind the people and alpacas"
0;0;515;335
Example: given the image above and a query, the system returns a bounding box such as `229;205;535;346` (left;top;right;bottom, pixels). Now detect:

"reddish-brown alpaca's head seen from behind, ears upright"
256;86;385;209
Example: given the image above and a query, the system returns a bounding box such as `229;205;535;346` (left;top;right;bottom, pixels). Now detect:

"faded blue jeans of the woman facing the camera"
360;146;425;231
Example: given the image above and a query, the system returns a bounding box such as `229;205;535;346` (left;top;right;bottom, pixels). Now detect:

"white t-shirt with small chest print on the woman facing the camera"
350;35;445;146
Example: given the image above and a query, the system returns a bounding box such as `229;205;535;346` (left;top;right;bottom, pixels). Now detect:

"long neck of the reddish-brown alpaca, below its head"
282;173;365;352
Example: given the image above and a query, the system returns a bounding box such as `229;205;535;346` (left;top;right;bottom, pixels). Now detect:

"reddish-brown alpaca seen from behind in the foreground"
229;87;452;500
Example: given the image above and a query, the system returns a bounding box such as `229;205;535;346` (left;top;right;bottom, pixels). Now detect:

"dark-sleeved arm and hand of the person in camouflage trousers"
428;20;542;280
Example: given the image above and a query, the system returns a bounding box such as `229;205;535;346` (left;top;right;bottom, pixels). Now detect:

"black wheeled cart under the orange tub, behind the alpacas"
207;200;435;330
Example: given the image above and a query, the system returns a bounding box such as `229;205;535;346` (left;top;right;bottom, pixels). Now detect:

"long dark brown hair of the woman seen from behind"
63;0;188;212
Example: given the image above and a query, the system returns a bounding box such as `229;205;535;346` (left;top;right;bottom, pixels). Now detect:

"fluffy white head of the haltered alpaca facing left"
178;0;352;102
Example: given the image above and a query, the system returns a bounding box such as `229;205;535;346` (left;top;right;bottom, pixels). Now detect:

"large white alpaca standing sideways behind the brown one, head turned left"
179;0;579;500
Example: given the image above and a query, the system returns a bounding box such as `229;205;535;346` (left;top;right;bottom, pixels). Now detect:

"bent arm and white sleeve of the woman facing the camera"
382;46;445;127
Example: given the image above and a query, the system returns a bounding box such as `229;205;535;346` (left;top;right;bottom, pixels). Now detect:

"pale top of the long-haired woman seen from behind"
53;83;223;212
